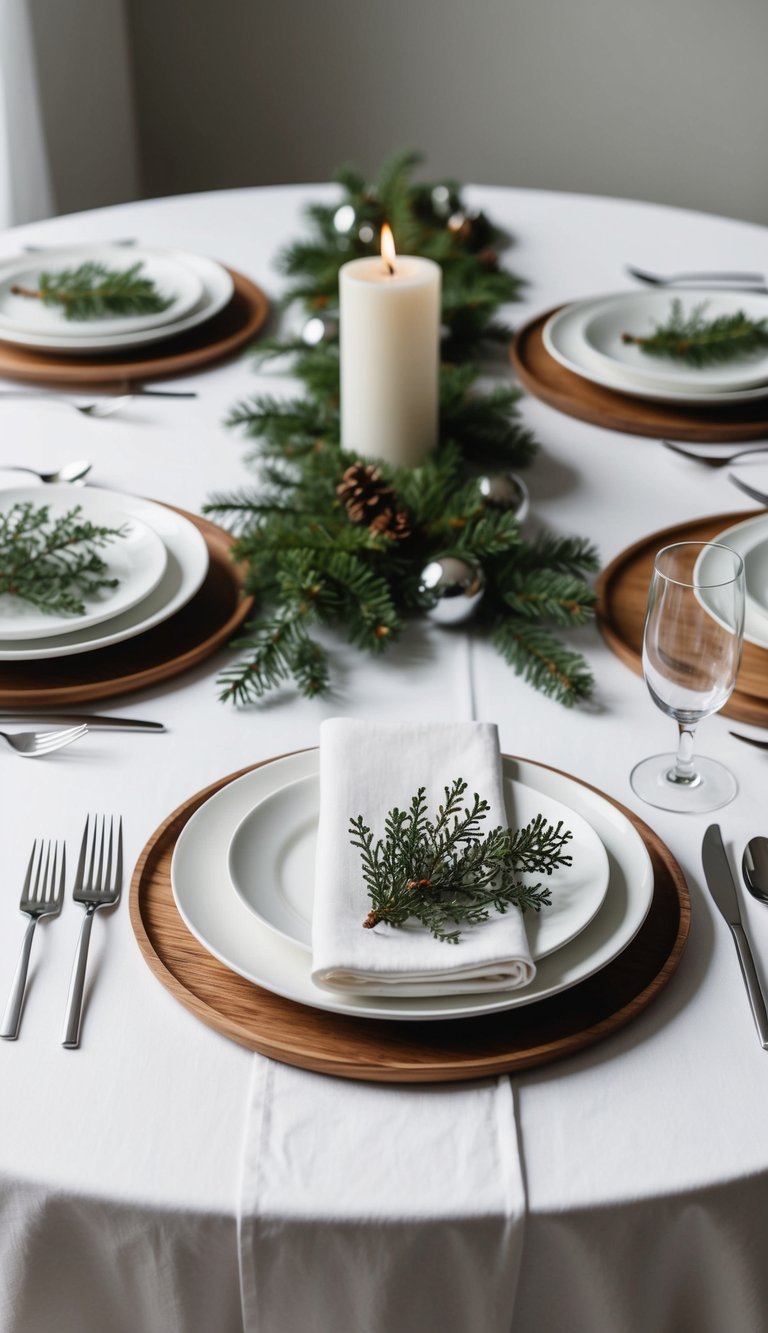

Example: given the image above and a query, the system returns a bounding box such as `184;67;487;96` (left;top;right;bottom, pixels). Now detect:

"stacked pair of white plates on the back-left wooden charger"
0;245;235;356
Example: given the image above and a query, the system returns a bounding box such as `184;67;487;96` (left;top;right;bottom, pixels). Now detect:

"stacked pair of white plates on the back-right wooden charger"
543;288;768;408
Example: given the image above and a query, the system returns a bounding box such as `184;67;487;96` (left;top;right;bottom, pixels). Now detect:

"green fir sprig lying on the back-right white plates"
621;299;768;367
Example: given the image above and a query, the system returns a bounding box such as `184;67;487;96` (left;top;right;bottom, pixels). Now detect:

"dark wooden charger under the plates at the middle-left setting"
0;505;252;710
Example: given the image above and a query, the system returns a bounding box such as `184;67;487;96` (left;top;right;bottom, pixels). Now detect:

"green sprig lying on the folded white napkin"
349;777;572;944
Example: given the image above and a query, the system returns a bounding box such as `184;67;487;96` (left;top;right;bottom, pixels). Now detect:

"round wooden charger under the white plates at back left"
0;268;269;388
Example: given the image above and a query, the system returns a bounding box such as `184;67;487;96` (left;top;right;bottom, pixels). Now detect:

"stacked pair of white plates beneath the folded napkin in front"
171;750;653;1021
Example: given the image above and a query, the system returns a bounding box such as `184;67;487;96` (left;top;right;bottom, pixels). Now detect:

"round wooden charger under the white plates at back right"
509;305;768;444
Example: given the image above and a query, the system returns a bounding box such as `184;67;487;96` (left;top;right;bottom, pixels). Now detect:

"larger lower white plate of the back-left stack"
0;251;235;356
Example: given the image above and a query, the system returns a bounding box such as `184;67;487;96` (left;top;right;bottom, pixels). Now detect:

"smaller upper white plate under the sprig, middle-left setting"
0;487;168;643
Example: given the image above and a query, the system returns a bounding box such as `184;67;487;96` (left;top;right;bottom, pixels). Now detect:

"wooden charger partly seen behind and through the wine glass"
597;509;768;726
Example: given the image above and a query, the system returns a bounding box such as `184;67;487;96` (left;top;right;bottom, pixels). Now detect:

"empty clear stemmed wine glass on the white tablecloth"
629;541;744;812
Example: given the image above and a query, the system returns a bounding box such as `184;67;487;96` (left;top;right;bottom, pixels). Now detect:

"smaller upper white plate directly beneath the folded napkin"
228;774;608;961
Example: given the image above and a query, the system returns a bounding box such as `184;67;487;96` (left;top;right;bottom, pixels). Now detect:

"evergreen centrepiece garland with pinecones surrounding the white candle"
205;152;597;705
